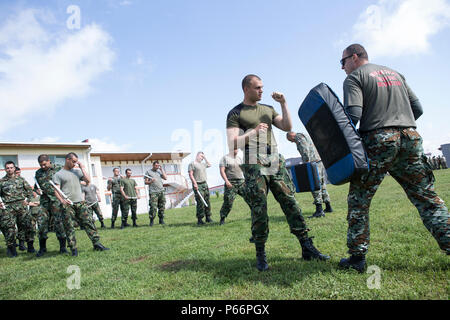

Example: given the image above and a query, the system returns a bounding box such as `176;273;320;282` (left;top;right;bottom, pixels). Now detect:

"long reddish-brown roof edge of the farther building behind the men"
91;151;190;162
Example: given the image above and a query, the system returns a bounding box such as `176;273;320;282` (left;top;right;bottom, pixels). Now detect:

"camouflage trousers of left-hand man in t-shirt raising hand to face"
64;201;100;249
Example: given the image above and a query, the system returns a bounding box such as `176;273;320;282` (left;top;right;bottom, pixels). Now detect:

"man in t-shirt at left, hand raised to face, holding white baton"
53;152;109;256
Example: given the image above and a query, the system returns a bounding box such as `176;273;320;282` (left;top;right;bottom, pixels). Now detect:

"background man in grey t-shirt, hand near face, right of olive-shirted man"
144;160;167;227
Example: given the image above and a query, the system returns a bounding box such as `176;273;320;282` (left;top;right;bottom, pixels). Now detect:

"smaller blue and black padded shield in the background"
291;162;320;192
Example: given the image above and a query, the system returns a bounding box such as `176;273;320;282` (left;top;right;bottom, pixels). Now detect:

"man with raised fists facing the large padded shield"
226;75;330;271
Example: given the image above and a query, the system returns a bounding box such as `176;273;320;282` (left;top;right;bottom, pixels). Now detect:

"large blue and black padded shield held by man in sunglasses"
298;83;369;185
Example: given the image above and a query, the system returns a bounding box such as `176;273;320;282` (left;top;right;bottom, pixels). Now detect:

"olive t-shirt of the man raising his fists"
227;103;278;158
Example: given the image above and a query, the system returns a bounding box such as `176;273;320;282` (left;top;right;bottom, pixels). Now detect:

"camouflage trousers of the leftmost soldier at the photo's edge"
0;200;35;247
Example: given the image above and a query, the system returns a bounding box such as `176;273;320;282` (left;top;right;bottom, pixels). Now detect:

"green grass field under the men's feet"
0;170;450;300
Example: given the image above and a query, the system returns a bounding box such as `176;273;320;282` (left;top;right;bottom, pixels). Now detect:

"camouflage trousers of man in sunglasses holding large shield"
347;128;450;255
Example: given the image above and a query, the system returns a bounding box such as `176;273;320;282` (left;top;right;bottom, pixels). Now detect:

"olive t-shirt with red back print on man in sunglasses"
344;63;418;132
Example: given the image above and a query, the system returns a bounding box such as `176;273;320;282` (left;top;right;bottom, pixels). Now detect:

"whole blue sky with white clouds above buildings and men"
0;0;450;185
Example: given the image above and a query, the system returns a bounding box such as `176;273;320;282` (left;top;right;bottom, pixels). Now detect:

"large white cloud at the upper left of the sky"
0;9;115;133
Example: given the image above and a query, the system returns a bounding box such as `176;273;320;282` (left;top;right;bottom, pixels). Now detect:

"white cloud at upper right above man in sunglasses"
352;0;450;57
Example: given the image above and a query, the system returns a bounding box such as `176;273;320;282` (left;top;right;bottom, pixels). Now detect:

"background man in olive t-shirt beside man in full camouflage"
120;169;141;229
